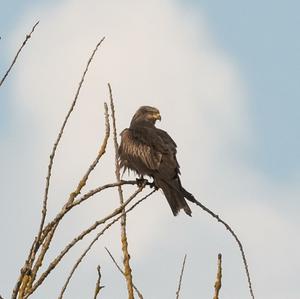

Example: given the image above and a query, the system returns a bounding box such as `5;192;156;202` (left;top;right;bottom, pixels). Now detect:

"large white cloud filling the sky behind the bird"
0;0;299;298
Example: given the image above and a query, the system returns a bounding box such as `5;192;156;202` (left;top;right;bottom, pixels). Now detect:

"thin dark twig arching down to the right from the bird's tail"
190;197;255;299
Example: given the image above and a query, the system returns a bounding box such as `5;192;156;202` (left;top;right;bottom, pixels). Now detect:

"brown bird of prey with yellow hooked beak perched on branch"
118;106;195;216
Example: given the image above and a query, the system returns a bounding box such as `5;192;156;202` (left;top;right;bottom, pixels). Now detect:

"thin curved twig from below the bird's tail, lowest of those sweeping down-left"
58;190;155;299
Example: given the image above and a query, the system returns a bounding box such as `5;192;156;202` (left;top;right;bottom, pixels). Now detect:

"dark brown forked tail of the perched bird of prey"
155;178;192;216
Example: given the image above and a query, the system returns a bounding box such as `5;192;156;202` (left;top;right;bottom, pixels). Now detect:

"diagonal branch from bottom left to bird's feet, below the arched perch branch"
24;185;151;298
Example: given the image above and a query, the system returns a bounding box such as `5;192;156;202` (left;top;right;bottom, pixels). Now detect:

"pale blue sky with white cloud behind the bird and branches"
0;0;300;299
